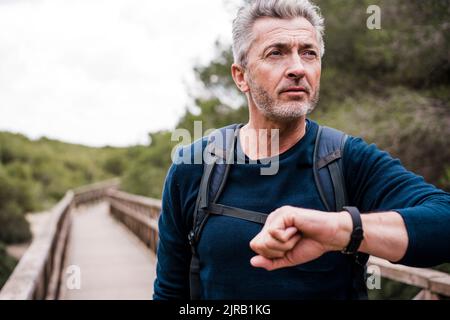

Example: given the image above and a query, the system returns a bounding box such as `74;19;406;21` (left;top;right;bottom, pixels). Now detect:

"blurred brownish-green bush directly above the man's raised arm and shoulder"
312;87;450;190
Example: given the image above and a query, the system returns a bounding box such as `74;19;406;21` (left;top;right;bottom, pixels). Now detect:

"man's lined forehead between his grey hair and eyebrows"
252;17;318;45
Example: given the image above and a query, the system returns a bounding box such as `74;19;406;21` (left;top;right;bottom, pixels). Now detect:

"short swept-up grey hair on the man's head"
233;0;325;67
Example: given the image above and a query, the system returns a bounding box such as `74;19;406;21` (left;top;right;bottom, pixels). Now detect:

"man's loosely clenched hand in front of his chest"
250;206;352;270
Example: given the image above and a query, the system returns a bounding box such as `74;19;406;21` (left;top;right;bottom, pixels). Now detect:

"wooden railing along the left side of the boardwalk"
0;179;119;300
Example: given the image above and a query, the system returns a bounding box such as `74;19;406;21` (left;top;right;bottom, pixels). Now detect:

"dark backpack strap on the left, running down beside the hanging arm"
188;124;242;300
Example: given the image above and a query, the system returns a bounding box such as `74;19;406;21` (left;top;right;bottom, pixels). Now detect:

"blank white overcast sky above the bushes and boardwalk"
0;0;241;146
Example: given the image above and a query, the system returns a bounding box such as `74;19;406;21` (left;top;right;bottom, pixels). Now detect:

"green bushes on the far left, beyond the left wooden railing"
0;132;125;244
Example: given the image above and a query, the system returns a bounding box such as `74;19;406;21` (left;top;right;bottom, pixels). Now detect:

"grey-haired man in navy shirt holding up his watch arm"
154;0;450;299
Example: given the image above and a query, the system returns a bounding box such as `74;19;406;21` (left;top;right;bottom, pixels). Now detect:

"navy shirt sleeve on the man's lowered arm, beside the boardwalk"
153;164;191;300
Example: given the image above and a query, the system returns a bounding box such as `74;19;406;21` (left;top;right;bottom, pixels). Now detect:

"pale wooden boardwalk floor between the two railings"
60;202;156;300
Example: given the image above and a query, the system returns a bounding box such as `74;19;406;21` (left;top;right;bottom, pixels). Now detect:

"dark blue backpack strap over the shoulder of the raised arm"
313;126;348;211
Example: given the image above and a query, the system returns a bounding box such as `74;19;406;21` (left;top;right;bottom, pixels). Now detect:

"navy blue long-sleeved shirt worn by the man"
154;120;450;299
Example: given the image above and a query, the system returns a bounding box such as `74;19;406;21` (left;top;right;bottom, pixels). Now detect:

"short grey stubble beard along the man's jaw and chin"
249;79;320;122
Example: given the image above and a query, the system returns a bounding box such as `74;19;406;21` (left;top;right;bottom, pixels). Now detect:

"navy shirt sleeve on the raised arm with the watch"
343;137;450;267
